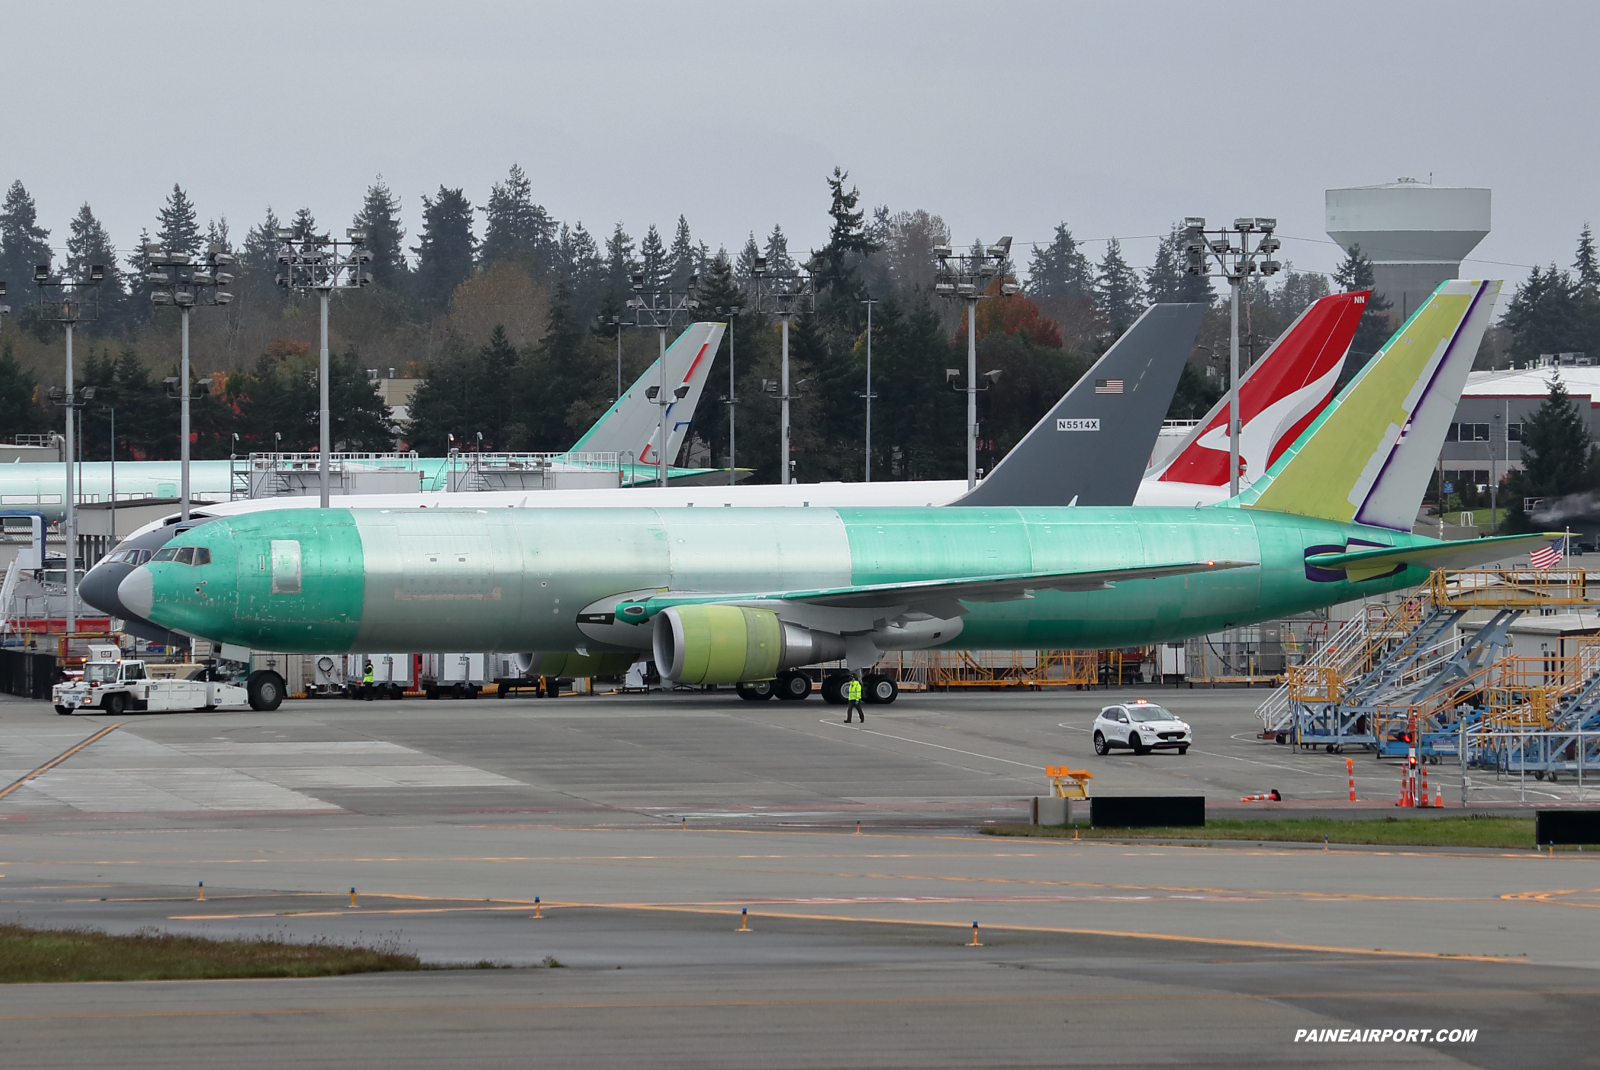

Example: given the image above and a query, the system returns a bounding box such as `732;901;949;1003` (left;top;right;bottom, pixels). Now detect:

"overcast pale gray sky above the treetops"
0;0;1600;292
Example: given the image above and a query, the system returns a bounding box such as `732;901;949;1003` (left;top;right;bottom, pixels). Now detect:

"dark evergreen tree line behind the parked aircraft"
0;166;1389;481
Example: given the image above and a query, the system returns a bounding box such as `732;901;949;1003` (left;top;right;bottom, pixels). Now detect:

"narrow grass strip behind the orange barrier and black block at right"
982;816;1533;848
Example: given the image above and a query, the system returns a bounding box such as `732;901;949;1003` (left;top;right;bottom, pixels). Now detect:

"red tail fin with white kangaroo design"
1144;289;1371;486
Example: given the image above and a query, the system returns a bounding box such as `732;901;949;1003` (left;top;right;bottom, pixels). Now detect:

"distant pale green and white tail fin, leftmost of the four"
573;323;726;465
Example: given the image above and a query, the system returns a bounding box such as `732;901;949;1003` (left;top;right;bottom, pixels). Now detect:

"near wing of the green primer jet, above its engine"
616;561;1256;624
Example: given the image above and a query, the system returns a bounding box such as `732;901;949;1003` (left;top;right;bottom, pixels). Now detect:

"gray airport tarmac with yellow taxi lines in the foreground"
0;689;1600;1067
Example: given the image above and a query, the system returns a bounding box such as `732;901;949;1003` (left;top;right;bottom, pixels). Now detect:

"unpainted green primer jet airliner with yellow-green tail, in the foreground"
118;281;1541;709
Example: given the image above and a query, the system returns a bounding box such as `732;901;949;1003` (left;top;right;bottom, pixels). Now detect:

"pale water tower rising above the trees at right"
1326;178;1490;325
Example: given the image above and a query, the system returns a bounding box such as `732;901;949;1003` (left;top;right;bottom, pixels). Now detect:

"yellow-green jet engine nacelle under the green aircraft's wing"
653;606;845;683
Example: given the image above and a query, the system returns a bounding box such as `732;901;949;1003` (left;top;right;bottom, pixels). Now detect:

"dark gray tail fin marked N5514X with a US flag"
950;304;1205;505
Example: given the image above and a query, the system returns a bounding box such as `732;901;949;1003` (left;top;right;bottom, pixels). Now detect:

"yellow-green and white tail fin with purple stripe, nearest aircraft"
1229;280;1501;531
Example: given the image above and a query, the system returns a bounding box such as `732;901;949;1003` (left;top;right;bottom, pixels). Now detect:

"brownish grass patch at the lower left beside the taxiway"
0;924;422;984
